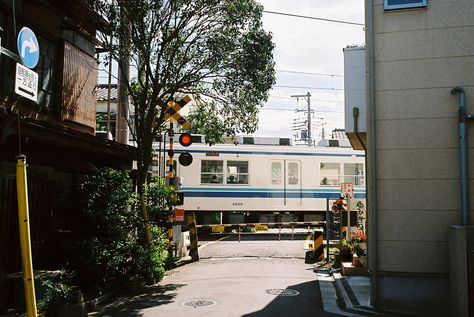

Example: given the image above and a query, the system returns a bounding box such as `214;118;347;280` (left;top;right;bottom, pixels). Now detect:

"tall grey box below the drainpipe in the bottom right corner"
449;226;474;317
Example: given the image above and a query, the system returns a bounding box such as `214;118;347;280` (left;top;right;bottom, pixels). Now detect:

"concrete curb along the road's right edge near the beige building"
332;272;399;317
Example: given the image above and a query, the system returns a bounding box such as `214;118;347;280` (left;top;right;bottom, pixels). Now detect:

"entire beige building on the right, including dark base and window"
362;0;474;316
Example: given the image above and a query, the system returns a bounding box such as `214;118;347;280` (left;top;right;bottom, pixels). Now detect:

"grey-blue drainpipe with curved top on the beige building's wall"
451;87;474;226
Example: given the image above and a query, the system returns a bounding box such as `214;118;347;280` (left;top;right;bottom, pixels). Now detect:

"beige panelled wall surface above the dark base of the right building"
373;0;474;274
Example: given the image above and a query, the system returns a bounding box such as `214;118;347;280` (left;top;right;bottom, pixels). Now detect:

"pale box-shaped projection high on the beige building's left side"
343;46;367;150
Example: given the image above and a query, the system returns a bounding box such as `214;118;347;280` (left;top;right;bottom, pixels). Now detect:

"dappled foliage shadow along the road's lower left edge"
89;284;186;317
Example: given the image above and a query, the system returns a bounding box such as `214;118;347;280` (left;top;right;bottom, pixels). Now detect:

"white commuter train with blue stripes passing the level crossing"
153;138;365;224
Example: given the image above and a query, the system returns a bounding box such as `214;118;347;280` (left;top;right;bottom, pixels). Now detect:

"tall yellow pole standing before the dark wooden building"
16;155;38;317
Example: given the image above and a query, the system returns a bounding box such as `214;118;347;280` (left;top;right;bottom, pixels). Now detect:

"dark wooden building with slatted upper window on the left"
0;0;134;292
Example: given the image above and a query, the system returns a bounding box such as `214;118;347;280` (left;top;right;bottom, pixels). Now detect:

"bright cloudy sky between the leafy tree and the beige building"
254;0;365;139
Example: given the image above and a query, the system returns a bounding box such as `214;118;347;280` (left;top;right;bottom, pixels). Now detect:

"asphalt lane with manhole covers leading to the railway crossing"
90;235;348;317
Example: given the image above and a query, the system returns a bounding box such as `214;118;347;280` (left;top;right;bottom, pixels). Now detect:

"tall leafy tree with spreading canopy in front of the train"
90;0;275;242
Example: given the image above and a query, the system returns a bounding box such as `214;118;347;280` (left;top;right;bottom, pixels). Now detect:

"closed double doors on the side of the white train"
270;160;301;207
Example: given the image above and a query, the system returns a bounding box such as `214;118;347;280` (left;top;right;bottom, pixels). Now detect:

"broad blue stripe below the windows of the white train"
183;190;365;199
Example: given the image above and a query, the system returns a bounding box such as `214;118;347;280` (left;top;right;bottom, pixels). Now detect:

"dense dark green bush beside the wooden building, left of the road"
72;168;166;296
